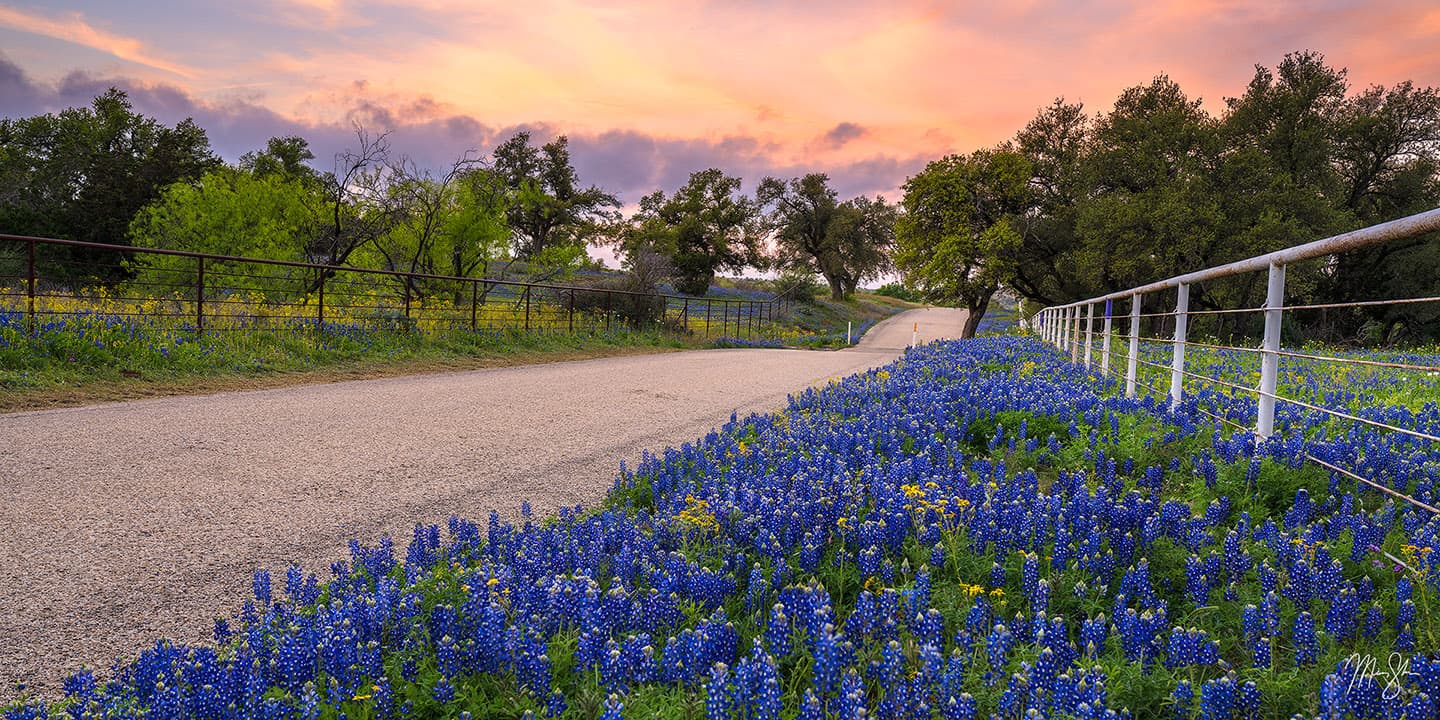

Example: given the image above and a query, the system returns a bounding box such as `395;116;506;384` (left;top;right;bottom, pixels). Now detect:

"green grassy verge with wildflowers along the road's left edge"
0;272;912;412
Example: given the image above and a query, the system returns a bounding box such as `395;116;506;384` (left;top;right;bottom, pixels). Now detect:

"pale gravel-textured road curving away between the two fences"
0;310;965;694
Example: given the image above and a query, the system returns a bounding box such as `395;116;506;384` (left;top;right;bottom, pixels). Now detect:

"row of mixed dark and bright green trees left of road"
0;89;894;298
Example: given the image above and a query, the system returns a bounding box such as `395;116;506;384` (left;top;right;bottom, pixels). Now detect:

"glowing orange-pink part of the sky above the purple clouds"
0;0;1440;194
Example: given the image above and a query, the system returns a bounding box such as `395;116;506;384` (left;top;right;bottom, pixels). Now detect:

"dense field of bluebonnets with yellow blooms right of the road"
4;329;1440;720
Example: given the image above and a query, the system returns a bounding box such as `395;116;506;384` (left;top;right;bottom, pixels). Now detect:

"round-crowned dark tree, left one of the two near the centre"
619;168;765;295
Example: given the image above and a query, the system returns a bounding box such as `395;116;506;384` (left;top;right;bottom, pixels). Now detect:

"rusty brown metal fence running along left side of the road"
0;235;788;338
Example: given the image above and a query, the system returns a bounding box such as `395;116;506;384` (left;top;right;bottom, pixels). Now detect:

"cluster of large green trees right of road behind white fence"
897;52;1440;341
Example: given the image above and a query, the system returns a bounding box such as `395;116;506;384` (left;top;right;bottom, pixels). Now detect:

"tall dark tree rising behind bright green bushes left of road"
494;131;621;265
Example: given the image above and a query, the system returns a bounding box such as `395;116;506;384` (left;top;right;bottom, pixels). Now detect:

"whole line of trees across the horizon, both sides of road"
0;52;1440;341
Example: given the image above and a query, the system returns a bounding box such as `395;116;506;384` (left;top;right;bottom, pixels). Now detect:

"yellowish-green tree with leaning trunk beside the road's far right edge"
894;147;1031;337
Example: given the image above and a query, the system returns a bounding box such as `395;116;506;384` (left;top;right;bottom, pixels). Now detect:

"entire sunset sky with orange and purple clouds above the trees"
0;0;1440;203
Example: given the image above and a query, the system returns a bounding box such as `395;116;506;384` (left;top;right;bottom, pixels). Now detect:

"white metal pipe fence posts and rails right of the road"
1027;209;1440;514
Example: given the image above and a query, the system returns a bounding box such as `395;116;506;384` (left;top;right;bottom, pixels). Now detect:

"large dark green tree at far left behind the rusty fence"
0;88;219;282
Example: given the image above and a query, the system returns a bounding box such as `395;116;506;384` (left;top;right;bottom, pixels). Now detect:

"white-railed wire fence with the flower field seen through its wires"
1027;209;1440;518
